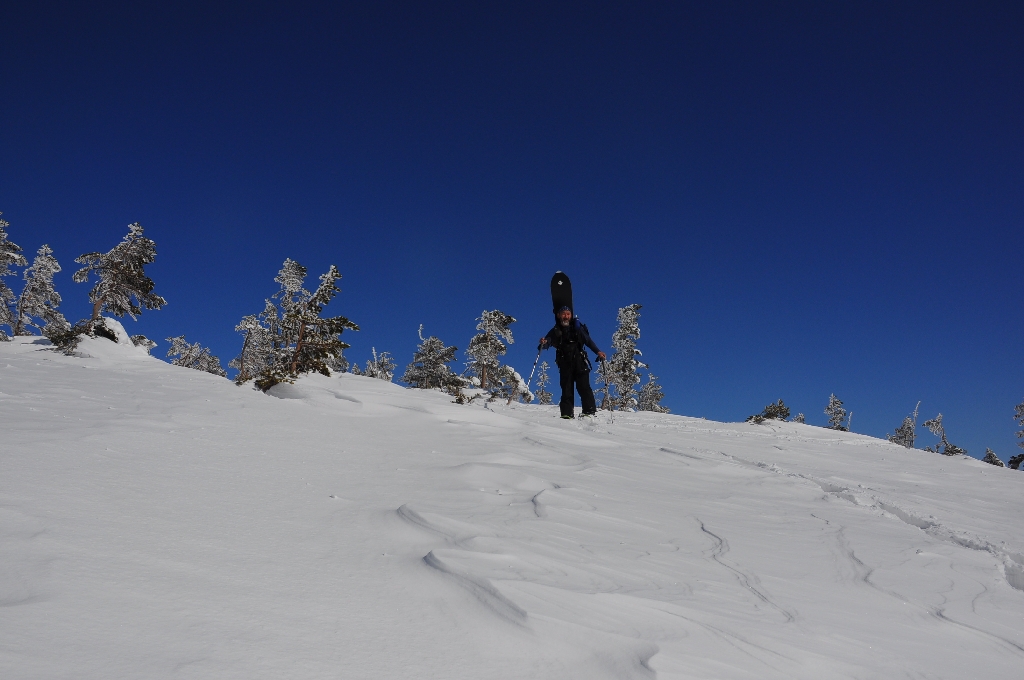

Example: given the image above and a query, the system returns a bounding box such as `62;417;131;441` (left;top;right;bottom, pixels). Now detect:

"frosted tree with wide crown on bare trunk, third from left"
73;222;167;321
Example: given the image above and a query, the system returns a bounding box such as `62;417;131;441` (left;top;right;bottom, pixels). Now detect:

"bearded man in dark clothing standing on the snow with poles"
541;307;604;418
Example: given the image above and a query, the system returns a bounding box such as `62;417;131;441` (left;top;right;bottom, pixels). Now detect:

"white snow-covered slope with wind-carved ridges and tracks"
6;327;1024;680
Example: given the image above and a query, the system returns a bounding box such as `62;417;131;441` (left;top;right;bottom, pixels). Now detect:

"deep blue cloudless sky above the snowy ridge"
0;2;1024;460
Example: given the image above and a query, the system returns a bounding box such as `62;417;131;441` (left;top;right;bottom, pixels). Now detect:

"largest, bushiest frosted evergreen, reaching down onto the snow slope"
230;259;359;392
